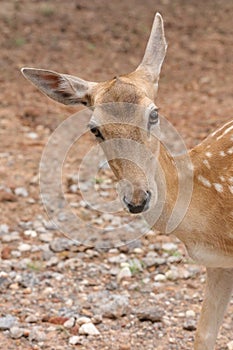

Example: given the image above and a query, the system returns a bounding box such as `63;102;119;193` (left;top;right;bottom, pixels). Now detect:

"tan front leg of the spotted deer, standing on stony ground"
194;268;233;350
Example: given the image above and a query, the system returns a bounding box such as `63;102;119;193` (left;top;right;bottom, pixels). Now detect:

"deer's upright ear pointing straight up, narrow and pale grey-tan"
137;12;167;83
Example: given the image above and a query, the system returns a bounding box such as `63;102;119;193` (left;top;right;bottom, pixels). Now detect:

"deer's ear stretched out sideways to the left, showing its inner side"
21;68;97;106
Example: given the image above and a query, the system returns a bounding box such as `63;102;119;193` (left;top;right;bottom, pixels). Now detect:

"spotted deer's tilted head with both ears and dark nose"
22;13;167;213
